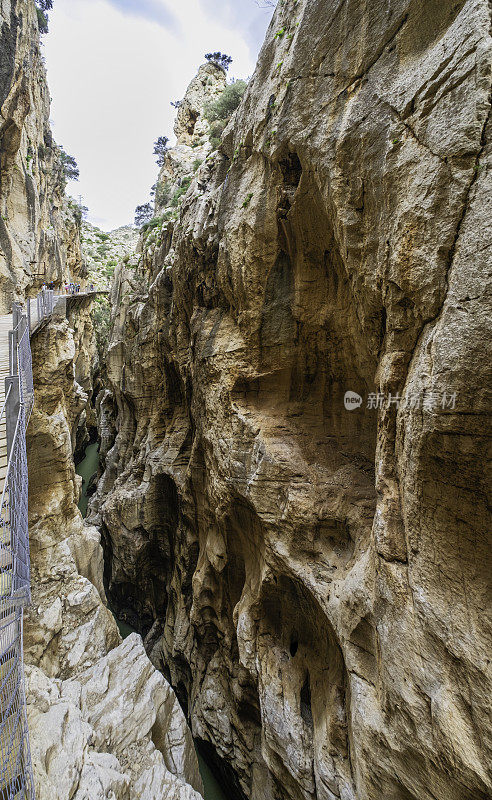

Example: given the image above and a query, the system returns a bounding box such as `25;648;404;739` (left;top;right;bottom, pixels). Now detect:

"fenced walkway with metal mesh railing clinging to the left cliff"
0;290;107;800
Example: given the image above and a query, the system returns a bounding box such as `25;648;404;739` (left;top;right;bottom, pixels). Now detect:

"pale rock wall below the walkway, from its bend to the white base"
24;300;202;800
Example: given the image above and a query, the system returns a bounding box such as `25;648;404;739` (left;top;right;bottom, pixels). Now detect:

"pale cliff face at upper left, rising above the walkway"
0;0;84;314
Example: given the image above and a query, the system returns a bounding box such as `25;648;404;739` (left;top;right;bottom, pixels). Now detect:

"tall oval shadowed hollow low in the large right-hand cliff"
259;575;352;797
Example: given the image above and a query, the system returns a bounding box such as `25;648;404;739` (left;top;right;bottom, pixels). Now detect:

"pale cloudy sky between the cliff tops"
43;0;272;230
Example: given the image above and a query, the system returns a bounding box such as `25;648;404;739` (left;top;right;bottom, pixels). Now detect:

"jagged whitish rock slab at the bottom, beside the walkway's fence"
27;634;201;800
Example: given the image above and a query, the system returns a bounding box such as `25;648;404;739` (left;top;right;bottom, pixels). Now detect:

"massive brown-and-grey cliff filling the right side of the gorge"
96;0;492;800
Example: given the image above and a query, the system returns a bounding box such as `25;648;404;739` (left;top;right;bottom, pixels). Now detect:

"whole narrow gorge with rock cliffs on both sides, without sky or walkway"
0;0;492;800
